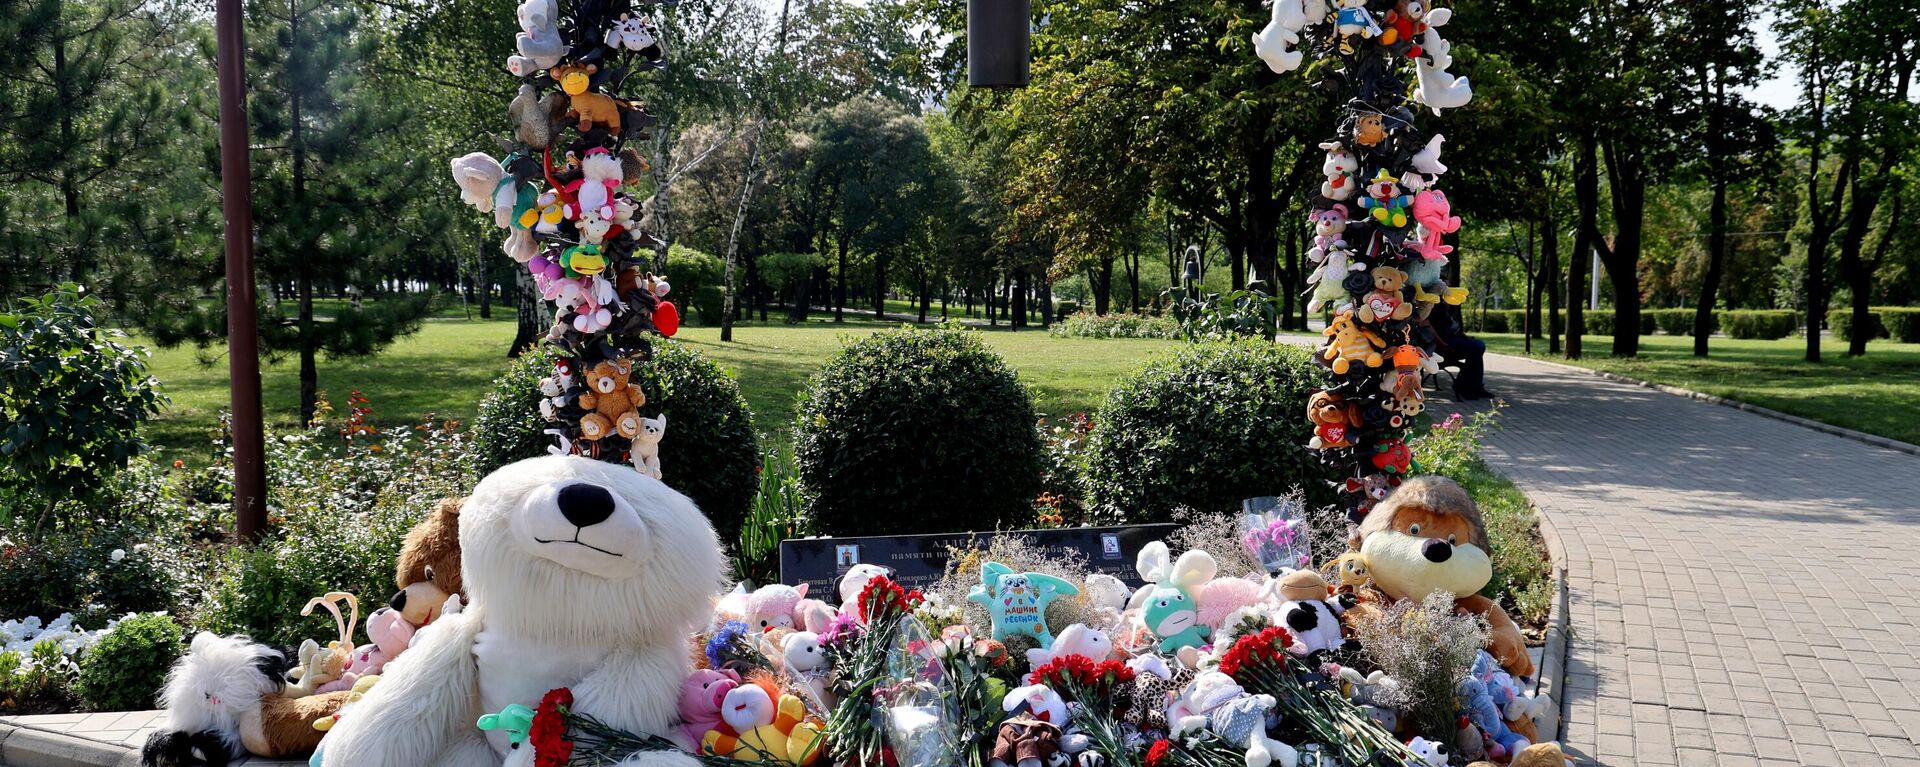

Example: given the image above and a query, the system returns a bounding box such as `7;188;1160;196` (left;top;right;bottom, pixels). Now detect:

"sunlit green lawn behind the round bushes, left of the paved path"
135;311;1175;459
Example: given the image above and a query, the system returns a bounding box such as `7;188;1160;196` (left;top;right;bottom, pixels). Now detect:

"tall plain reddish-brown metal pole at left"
213;0;267;540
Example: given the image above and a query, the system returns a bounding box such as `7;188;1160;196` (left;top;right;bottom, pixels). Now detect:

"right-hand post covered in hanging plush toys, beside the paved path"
1254;0;1473;523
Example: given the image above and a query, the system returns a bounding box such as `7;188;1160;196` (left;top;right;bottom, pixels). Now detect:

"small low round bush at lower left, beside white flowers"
79;613;186;711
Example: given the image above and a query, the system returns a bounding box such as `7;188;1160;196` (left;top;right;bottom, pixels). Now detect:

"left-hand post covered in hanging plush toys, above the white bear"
453;0;680;470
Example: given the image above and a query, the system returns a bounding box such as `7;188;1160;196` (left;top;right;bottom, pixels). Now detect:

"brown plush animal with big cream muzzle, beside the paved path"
1352;477;1534;677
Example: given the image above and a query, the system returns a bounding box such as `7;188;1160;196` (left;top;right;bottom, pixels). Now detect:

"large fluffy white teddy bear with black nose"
321;456;722;767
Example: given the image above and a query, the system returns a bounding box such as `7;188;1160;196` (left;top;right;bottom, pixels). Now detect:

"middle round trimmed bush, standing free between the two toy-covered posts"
795;329;1041;534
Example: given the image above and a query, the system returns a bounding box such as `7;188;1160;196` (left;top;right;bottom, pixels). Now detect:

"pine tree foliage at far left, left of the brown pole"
0;0;198;297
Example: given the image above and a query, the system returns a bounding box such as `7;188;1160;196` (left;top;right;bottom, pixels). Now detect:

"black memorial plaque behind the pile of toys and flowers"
780;525;1179;602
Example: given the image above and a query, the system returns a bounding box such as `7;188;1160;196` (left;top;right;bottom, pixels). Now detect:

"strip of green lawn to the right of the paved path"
1476;334;1920;442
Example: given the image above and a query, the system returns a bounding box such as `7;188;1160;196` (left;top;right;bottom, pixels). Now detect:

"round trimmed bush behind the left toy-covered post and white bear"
474;342;760;540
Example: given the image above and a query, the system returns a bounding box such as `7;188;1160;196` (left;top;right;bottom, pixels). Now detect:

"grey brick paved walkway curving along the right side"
1451;358;1920;767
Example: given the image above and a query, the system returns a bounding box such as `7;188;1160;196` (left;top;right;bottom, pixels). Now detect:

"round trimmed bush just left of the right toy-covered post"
1081;342;1338;523
